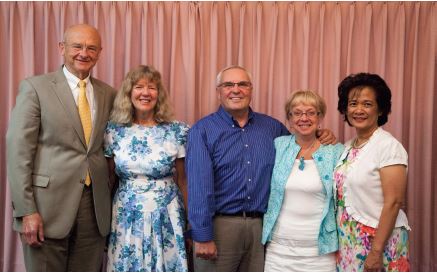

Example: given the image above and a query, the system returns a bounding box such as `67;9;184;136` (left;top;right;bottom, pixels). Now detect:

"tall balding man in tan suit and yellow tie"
6;25;115;271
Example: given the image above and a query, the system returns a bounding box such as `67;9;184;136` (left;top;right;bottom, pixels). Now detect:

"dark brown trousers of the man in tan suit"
21;186;106;272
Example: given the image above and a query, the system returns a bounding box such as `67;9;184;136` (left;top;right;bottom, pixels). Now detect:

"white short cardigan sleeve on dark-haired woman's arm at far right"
379;138;408;168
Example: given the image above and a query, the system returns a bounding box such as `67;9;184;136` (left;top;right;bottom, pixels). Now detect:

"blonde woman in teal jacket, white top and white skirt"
262;91;344;272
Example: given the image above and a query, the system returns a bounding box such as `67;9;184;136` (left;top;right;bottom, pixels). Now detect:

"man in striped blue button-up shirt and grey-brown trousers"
186;66;335;272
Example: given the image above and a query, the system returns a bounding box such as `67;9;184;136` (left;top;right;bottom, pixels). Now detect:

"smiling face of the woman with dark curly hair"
346;87;380;135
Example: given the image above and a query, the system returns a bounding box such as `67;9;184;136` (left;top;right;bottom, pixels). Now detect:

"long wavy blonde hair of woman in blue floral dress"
109;65;173;124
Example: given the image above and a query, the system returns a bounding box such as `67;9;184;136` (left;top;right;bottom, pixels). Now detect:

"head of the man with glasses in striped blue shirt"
217;68;253;116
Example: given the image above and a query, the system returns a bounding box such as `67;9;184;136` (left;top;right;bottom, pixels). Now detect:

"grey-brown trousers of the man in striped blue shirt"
194;216;264;272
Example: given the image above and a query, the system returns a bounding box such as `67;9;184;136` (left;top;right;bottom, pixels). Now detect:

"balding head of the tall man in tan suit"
59;25;101;79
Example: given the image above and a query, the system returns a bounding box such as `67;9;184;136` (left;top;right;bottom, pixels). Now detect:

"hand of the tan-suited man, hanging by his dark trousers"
22;213;44;247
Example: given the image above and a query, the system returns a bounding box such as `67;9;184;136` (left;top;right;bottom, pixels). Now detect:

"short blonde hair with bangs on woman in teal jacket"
285;90;326;119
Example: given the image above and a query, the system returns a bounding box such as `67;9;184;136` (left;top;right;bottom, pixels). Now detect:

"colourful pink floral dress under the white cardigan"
334;148;410;272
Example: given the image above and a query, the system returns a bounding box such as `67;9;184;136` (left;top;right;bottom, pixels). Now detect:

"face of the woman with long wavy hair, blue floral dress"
131;78;158;118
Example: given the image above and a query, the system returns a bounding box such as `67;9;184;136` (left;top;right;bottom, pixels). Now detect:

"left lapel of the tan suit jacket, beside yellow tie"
52;69;86;147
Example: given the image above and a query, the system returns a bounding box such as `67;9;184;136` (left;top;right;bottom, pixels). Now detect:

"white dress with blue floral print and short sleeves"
104;122;188;272
